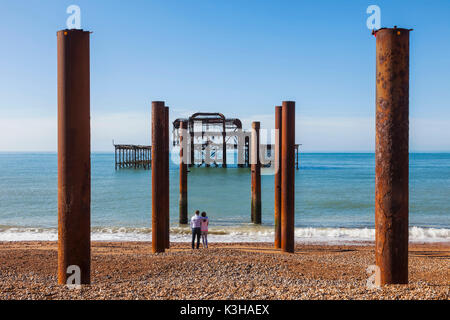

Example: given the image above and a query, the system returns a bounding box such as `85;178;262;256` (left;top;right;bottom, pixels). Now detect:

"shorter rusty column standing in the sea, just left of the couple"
179;121;188;224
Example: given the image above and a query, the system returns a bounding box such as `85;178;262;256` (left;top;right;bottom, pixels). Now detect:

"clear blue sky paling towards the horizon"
0;0;450;152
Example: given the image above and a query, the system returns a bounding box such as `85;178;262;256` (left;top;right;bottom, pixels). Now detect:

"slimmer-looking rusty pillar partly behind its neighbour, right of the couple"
274;107;282;249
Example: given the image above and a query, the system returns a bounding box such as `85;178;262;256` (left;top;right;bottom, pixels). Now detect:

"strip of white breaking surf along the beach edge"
0;226;450;244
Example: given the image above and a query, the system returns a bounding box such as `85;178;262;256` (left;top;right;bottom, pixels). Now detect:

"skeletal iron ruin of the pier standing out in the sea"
113;112;300;170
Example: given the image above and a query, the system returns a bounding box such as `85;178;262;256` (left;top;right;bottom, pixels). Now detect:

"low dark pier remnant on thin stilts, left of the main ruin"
113;143;152;170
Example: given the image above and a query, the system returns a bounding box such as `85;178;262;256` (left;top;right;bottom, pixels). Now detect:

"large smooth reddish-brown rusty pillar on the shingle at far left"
57;30;91;284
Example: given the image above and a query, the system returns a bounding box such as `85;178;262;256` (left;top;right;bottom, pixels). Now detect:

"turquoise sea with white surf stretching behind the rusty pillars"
0;153;450;242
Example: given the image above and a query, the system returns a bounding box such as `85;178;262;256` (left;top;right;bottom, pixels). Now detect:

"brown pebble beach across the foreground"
0;242;450;300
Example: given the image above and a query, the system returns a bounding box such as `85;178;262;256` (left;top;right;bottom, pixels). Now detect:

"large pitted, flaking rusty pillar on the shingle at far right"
375;28;410;285
